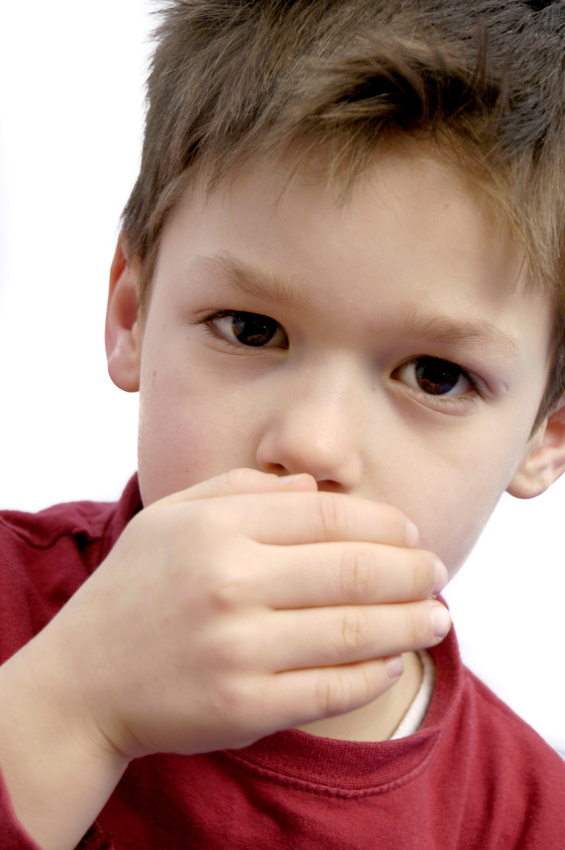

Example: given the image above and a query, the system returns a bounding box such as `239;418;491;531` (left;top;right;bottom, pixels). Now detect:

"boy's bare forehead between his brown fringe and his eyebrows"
160;144;525;286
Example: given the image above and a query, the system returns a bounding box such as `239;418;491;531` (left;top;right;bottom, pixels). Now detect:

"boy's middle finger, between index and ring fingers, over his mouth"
254;542;448;609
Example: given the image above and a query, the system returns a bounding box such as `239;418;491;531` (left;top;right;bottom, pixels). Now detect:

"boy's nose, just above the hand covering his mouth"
257;361;364;493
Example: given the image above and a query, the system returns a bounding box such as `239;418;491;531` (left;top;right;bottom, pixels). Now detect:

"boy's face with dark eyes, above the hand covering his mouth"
111;147;551;572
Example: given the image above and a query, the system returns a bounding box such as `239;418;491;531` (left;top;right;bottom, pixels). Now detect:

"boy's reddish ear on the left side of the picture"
106;239;143;393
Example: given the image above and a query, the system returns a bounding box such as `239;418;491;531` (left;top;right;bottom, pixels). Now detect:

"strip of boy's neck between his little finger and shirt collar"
300;652;422;741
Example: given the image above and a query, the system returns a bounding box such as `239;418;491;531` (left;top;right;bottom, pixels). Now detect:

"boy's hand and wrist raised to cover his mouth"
0;470;446;850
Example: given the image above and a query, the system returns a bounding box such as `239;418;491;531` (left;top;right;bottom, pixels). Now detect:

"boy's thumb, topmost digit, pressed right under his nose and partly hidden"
160;469;318;504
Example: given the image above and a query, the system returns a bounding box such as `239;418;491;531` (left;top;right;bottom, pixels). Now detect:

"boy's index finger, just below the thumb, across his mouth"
234;491;418;546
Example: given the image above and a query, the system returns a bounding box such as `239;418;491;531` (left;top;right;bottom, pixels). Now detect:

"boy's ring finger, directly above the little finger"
257;600;451;672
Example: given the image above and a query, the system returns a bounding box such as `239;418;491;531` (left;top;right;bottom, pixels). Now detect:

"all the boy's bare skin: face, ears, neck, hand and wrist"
0;142;565;850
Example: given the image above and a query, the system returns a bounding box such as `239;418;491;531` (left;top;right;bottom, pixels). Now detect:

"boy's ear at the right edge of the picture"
507;397;565;499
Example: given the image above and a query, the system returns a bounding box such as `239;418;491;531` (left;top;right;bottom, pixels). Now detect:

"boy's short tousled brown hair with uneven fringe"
122;0;565;424
